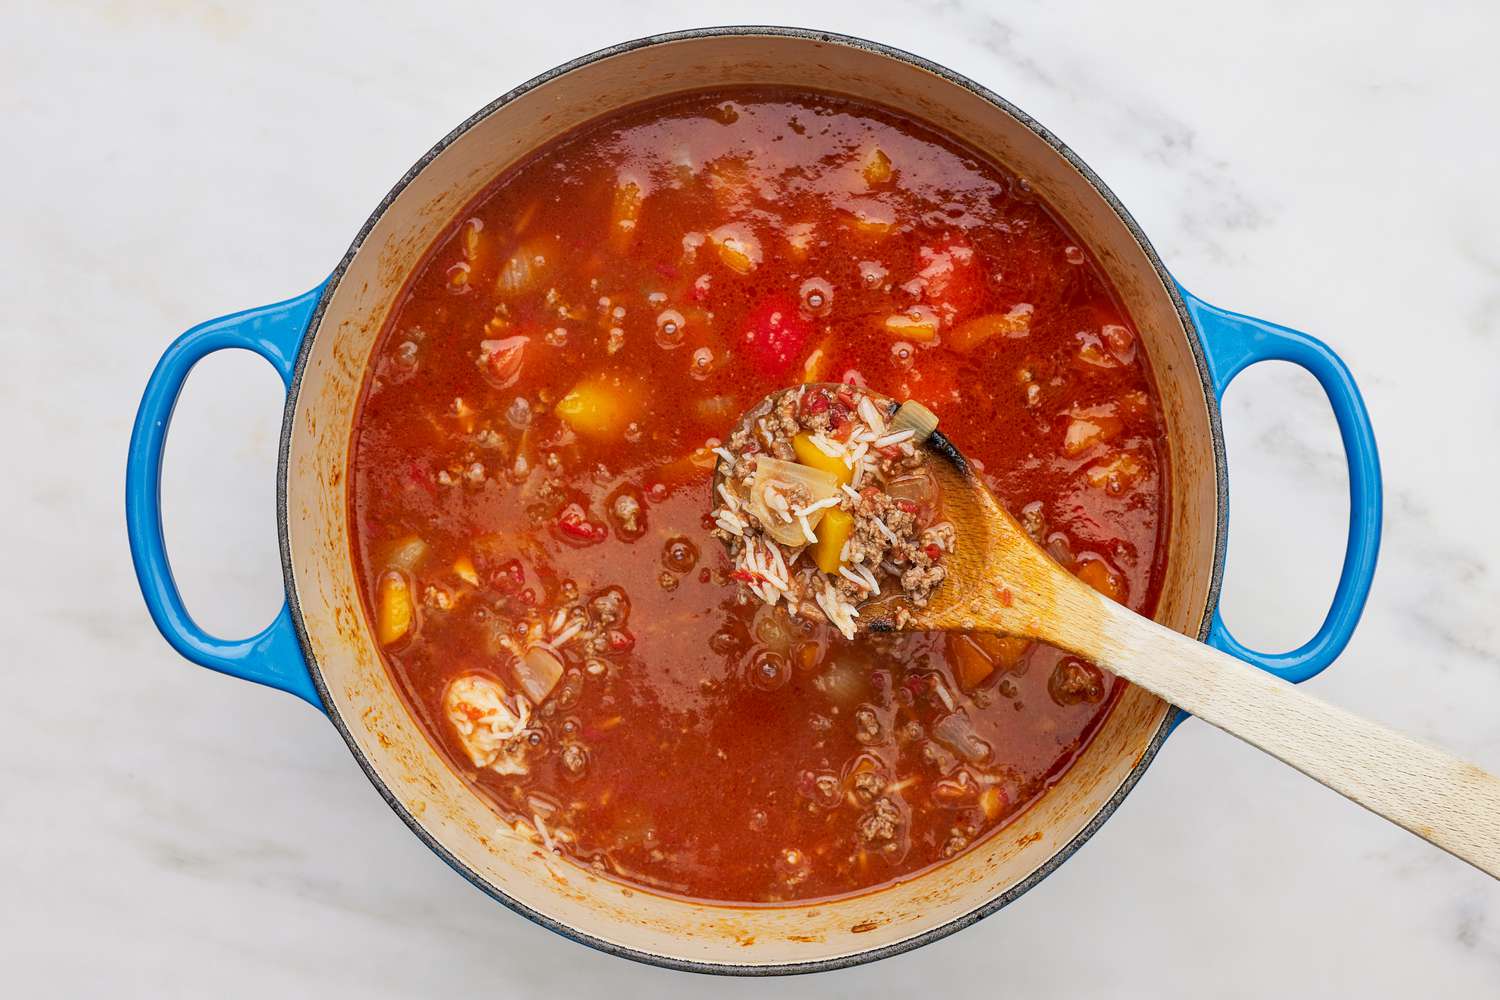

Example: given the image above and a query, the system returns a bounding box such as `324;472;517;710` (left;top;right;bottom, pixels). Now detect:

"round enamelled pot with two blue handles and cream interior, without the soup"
126;27;1380;975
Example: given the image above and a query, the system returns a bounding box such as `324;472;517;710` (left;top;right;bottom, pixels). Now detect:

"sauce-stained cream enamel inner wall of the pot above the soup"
285;31;1218;966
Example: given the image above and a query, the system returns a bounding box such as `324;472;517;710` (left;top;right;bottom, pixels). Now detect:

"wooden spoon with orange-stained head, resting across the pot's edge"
714;390;1500;879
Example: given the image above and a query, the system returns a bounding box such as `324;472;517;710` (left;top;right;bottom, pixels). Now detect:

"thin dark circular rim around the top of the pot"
276;24;1229;976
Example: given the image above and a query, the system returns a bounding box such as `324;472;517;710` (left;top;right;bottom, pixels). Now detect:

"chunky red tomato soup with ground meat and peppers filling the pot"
350;90;1167;903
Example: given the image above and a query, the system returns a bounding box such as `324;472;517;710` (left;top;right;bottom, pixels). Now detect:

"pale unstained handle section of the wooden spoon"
1079;598;1500;879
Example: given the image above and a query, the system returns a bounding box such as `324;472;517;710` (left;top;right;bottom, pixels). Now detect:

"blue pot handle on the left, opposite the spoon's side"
125;285;323;711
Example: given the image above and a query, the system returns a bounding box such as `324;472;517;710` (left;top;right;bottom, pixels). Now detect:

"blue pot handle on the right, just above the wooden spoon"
1178;285;1382;684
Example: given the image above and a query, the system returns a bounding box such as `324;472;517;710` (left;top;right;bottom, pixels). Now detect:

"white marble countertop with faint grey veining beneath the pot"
0;0;1500;999
